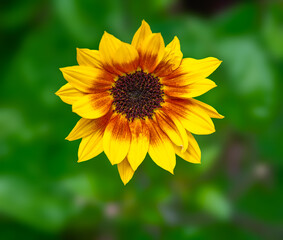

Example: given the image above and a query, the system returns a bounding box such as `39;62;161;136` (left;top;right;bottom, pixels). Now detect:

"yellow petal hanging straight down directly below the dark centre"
127;119;149;171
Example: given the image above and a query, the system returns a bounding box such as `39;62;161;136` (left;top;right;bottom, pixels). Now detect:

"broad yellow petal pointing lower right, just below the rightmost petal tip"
163;99;215;134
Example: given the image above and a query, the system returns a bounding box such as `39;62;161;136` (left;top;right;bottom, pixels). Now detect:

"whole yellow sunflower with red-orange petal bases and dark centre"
56;21;223;184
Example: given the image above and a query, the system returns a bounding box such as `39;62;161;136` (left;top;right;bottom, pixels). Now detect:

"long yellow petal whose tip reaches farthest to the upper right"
161;57;222;87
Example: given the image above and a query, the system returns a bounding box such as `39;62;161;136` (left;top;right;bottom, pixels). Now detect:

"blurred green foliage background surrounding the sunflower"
0;0;283;240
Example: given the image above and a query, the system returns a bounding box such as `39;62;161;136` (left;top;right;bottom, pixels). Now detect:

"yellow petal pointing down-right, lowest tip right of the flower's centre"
147;120;176;174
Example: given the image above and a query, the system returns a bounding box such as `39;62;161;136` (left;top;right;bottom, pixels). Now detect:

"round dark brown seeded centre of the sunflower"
110;70;164;121
